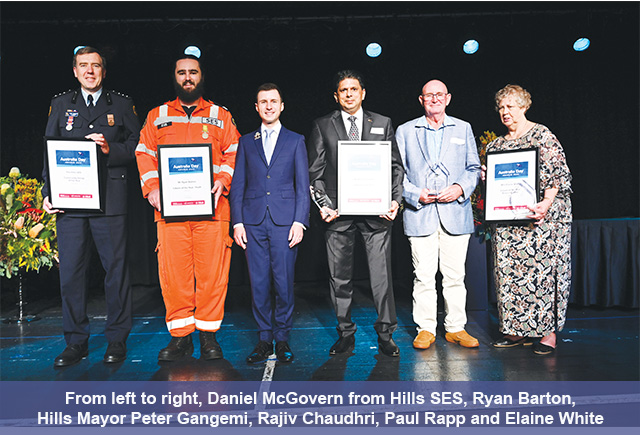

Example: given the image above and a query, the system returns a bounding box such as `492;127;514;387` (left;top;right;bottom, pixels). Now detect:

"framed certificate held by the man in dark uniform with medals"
44;137;104;213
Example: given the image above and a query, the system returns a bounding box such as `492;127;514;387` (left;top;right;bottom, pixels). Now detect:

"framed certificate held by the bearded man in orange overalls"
158;144;215;219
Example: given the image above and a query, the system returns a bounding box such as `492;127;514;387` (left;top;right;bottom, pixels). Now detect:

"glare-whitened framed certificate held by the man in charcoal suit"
338;141;391;216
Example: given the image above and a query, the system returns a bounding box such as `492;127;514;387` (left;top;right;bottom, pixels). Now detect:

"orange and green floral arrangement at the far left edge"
0;167;58;278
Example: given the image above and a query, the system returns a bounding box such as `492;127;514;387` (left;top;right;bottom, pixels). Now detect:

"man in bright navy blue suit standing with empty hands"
230;83;310;364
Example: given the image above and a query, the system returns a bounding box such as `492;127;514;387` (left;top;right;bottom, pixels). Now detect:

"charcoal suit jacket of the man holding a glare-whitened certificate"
309;110;404;231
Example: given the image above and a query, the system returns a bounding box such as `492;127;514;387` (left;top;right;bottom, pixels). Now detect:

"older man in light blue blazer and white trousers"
396;80;480;349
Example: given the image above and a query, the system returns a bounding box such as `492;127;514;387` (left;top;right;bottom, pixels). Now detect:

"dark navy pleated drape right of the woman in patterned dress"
570;219;640;308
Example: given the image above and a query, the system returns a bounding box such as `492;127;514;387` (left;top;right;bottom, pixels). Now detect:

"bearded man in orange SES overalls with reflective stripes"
136;54;240;361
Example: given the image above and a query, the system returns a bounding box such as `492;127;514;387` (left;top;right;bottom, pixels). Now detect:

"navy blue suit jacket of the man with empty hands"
229;127;310;226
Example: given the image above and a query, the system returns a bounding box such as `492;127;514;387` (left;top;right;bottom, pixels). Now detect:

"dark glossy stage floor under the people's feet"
0;282;640;381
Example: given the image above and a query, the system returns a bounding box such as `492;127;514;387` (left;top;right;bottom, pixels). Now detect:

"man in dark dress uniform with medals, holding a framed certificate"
42;47;140;367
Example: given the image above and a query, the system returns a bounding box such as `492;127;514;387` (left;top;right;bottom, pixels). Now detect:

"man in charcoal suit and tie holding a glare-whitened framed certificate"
309;70;404;357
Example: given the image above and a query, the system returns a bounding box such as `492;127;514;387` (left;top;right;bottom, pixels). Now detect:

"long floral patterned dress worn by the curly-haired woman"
487;124;572;337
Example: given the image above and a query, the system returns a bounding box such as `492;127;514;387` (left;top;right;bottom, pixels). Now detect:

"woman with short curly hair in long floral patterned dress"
487;85;571;355
